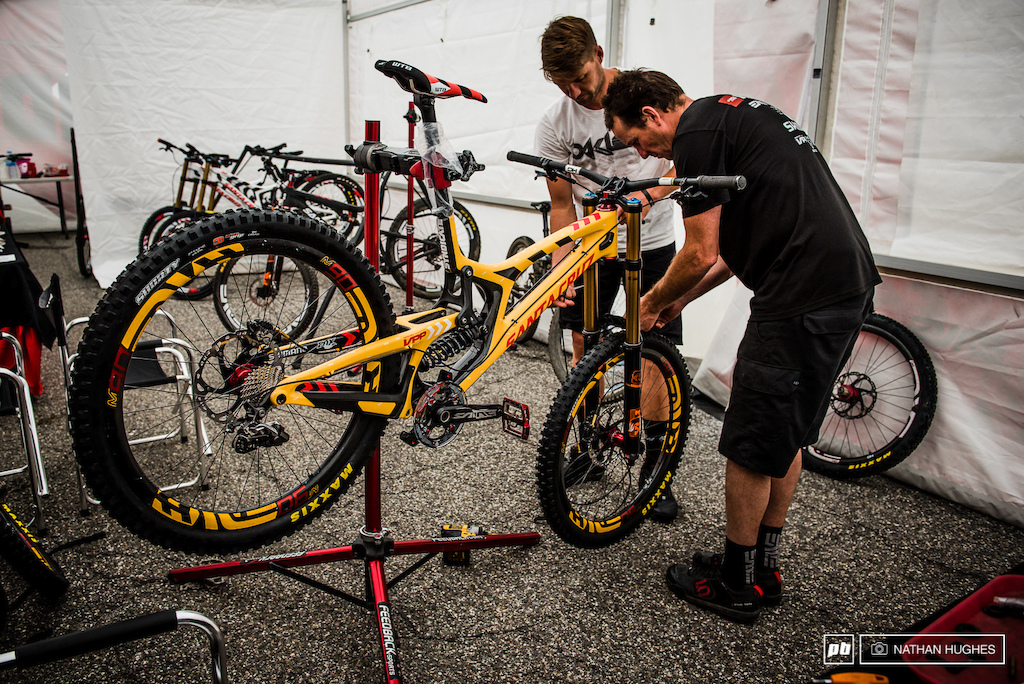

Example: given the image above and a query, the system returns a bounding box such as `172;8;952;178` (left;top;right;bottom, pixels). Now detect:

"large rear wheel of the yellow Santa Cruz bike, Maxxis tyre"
71;205;398;553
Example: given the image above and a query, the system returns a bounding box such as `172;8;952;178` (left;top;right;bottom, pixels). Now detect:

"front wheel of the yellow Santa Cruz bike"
537;333;690;548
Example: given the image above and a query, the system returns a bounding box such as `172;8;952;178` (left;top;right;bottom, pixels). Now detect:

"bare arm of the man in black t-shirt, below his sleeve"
640;206;732;330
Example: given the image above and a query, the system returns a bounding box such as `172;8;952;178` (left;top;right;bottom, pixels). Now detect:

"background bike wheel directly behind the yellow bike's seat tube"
381;194;480;299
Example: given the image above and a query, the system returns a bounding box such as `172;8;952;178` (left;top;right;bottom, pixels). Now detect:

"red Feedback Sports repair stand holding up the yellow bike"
169;121;541;684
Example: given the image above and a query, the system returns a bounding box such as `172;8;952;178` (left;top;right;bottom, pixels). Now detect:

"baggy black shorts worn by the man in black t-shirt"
718;289;874;477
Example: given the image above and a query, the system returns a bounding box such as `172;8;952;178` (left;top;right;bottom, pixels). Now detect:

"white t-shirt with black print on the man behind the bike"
536;90;678;252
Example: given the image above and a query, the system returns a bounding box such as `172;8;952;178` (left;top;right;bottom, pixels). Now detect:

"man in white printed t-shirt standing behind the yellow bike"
537;16;682;522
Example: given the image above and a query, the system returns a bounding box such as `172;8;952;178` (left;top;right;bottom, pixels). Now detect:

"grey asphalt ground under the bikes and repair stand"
6;234;1024;684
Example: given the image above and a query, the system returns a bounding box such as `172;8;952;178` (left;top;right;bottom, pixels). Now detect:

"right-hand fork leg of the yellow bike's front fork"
624;200;641;456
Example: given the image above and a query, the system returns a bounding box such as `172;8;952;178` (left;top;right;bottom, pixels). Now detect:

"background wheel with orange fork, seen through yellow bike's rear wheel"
213;254;319;340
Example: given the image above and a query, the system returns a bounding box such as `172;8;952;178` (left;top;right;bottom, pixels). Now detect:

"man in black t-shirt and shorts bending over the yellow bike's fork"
603;71;881;622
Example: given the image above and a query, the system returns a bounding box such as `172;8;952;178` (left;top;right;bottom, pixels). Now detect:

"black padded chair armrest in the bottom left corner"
14;610;178;668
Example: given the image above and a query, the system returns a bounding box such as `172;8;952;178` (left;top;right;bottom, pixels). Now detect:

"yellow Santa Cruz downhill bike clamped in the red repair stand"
71;61;744;553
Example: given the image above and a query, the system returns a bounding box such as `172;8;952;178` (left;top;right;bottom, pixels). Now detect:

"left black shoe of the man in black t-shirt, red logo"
666;552;761;624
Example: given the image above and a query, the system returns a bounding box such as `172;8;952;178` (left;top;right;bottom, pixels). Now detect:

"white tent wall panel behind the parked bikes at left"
61;0;346;287
